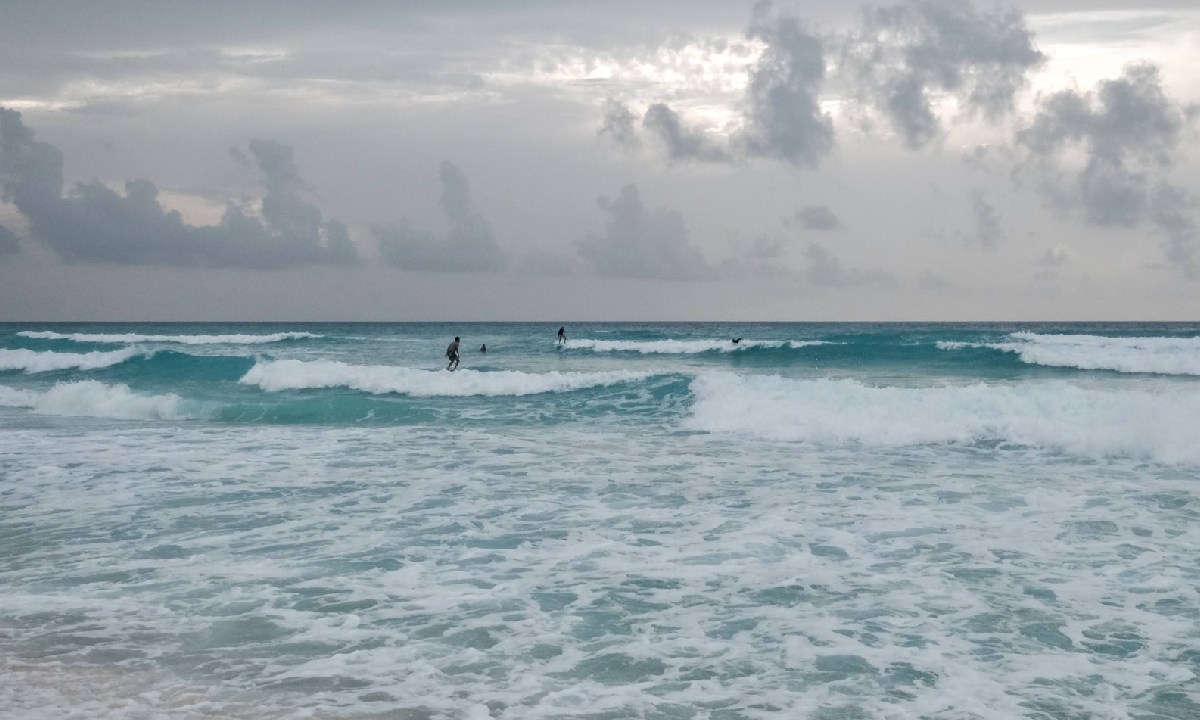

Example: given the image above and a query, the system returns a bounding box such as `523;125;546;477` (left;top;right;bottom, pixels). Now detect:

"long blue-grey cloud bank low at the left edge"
0;108;358;269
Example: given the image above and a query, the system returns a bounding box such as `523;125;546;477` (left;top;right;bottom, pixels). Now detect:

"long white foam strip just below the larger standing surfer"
241;360;649;397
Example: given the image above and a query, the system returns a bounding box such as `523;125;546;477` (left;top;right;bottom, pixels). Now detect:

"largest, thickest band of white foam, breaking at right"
686;373;1200;463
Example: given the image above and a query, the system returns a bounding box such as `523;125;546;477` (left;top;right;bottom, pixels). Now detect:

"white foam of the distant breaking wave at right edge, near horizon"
937;332;1200;376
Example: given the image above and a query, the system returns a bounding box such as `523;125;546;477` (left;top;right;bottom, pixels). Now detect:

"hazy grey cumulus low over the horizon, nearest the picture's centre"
578;185;713;280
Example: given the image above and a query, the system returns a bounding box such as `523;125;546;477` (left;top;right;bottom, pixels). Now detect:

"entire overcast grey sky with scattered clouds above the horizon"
0;0;1200;323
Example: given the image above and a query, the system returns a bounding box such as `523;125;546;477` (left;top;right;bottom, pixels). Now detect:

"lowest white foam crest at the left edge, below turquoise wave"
0;380;204;420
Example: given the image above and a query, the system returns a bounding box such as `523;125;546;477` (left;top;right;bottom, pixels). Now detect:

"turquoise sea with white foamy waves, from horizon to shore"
0;322;1200;720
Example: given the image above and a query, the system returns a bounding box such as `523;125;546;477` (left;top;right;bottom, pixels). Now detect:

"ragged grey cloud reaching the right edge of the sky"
1016;62;1198;275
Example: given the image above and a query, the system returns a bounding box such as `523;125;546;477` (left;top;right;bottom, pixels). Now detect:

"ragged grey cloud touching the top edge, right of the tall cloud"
845;0;1044;149
